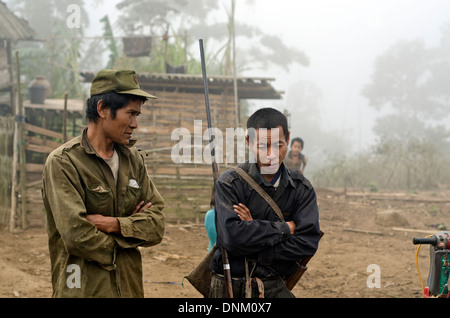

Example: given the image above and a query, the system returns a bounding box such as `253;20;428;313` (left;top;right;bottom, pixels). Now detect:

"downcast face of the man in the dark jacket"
247;126;289;175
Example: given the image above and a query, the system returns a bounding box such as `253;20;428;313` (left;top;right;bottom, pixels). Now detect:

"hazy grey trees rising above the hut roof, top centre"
113;0;309;75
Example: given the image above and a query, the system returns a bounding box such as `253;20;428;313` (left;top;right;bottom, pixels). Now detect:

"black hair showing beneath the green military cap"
86;92;147;123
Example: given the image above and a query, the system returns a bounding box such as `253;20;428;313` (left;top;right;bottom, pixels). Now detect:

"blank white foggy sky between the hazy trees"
82;0;450;171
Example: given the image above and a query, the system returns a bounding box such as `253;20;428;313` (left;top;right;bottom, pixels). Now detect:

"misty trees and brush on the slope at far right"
314;25;450;190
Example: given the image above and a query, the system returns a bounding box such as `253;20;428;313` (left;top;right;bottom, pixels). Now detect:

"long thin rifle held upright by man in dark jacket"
199;39;233;298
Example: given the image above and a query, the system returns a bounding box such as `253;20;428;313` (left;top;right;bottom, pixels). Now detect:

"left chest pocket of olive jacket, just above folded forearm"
85;185;114;216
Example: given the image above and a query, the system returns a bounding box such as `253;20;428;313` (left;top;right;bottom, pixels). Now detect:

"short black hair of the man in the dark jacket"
247;107;289;141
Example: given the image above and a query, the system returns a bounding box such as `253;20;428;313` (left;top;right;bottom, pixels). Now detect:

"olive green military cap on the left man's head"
91;69;157;99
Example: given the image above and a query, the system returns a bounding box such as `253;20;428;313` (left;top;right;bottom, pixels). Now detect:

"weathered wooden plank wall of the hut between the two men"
134;91;241;222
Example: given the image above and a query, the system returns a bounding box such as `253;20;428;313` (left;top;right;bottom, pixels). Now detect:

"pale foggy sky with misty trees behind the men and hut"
6;0;450;188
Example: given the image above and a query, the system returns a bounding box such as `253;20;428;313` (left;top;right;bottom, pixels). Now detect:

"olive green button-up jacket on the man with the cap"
42;129;165;297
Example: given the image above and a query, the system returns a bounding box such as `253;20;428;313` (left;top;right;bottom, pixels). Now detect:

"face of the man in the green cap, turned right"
103;100;142;145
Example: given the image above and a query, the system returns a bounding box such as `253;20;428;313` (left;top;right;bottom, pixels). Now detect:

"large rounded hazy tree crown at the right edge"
362;40;450;147
